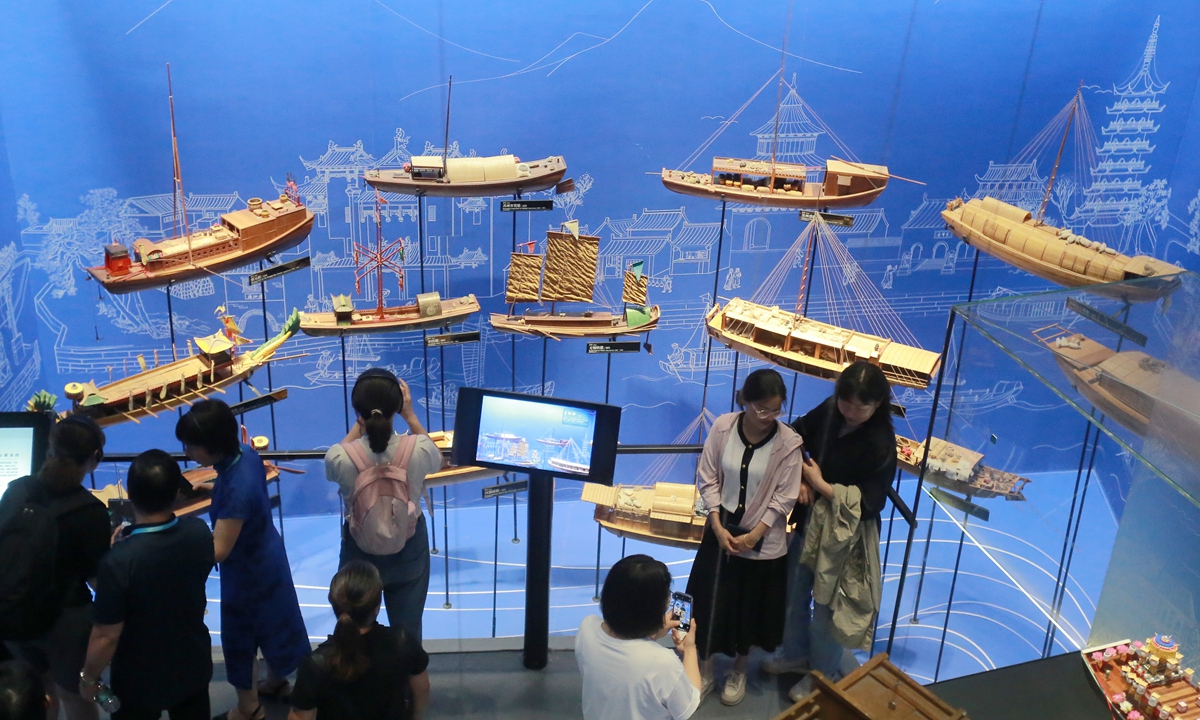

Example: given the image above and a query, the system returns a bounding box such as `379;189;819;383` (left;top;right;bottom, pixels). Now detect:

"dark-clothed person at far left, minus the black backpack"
5;416;112;720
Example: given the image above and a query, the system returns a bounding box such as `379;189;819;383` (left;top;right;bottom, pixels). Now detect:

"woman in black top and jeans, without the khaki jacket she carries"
763;361;896;696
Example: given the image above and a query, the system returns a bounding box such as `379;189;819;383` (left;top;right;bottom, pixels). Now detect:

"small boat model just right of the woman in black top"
896;436;1030;500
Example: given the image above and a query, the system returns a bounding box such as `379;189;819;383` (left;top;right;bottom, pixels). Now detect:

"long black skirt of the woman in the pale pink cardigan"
688;527;787;660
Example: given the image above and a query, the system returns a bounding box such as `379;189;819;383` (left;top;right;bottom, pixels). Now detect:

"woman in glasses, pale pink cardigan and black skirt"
688;368;803;706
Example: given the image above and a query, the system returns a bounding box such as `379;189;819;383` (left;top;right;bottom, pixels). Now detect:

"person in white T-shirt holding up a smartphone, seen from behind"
575;554;701;720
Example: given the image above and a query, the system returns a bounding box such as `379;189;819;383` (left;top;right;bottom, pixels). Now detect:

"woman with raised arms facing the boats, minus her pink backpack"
325;367;442;643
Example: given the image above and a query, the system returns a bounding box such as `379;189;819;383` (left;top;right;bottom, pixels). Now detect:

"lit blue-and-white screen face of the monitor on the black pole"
475;396;596;475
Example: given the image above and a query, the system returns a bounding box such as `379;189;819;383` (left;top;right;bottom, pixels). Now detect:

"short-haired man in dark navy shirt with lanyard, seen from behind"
79;450;214;720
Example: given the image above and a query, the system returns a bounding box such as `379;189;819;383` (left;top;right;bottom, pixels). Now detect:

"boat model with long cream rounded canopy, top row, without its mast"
362;155;566;198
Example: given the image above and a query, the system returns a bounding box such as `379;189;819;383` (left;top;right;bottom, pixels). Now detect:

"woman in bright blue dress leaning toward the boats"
175;400;311;720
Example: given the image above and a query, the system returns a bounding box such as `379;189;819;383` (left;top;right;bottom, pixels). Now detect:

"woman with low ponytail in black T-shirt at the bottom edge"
288;560;430;720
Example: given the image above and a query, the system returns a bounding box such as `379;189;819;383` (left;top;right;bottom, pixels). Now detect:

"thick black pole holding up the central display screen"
521;473;554;670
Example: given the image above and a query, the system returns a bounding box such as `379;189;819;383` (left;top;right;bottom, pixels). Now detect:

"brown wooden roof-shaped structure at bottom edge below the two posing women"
774;653;967;720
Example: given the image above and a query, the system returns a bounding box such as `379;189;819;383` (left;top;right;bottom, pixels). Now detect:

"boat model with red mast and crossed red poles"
300;191;479;336
